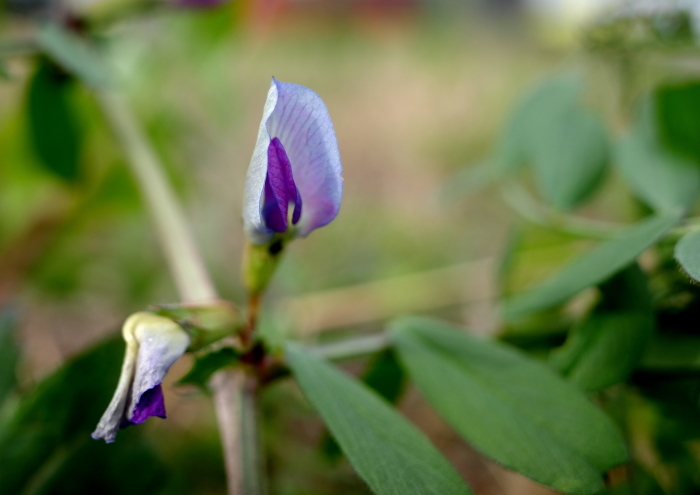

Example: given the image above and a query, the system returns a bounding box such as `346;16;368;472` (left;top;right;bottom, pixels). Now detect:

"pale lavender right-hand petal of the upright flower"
267;78;343;236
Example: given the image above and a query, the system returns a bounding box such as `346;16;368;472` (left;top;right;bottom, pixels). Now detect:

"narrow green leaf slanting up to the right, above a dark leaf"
503;212;681;320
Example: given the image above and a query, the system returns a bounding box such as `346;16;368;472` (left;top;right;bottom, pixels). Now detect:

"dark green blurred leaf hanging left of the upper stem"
27;59;83;181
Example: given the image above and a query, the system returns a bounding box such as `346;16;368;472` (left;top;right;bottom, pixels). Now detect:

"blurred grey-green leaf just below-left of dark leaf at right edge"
615;104;700;210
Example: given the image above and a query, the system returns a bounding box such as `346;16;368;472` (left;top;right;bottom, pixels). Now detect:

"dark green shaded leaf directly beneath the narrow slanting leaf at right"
550;264;654;390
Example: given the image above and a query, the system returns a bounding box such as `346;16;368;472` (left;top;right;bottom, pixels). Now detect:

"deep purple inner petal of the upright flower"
262;138;301;232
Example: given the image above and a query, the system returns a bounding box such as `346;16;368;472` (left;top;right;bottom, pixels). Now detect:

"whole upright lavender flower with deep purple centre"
243;78;343;245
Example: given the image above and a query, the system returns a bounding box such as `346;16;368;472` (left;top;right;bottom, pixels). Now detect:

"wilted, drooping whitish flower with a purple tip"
92;312;190;443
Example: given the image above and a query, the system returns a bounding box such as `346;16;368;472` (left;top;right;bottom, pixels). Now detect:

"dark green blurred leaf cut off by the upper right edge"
654;81;700;161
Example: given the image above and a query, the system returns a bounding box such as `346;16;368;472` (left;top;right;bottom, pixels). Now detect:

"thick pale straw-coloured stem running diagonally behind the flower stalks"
97;90;264;495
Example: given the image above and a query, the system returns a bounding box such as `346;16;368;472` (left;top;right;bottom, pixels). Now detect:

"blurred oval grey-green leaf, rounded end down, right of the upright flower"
532;108;609;210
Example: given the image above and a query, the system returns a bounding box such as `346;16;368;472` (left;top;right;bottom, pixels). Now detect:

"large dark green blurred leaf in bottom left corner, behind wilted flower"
0;338;162;495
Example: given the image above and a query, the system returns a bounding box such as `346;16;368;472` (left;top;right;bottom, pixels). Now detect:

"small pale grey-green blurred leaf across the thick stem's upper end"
37;23;111;88
